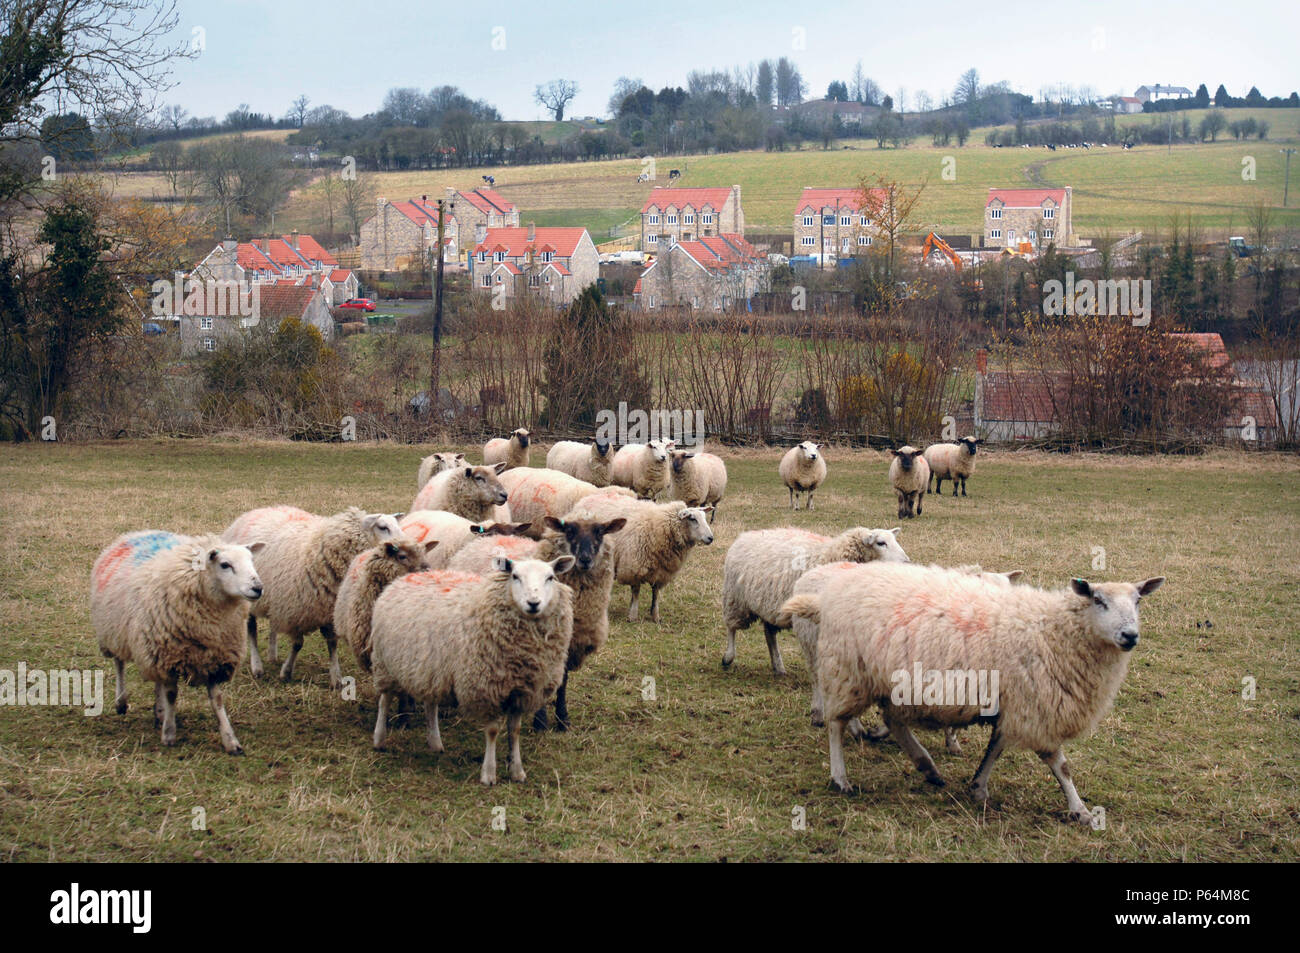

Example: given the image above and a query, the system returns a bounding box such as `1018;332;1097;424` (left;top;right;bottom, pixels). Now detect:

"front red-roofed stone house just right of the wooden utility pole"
469;224;601;304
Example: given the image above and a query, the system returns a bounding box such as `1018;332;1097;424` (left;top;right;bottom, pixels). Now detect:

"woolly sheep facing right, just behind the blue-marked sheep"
221;506;402;689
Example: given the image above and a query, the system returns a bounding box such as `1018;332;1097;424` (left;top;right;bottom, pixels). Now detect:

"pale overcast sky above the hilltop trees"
160;0;1300;121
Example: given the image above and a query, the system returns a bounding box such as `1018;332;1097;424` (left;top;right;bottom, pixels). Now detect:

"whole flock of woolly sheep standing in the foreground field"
90;429;1164;823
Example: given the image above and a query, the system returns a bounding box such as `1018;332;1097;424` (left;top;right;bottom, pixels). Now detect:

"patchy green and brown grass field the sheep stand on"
0;441;1300;862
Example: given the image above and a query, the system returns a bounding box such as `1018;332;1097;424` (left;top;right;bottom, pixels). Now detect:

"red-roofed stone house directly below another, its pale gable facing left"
632;233;772;311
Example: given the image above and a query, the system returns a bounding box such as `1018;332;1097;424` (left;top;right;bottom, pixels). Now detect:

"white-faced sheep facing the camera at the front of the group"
371;556;575;784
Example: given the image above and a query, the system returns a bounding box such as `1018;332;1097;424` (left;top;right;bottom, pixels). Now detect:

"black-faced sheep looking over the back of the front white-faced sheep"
447;516;627;731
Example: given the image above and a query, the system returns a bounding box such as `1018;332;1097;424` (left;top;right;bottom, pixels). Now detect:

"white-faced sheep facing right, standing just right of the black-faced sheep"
564;493;714;623
